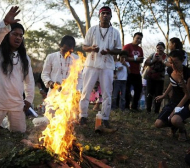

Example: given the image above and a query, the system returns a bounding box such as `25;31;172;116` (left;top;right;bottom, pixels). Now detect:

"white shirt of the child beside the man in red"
115;61;130;80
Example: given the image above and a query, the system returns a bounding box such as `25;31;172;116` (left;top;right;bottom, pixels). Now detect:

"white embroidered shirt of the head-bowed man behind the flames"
41;51;82;90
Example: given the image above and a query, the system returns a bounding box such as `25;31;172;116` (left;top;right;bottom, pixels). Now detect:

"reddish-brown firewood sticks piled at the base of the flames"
21;139;111;168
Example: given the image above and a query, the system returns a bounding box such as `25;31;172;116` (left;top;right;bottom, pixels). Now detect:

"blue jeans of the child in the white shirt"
112;80;127;111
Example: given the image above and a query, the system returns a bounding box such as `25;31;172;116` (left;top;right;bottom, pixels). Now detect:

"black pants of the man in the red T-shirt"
125;74;142;109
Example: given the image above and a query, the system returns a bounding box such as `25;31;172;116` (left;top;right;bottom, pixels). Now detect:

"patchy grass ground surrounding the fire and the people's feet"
0;90;190;168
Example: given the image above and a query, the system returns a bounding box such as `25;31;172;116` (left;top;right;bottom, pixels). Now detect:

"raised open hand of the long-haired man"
4;6;20;25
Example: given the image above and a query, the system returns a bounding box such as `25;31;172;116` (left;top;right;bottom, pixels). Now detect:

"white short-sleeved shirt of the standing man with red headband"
84;25;122;70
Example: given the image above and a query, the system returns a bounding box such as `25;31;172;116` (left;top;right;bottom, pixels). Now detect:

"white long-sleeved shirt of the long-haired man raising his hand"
0;52;34;111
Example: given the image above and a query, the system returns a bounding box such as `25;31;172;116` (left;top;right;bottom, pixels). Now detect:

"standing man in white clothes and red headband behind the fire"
79;6;122;127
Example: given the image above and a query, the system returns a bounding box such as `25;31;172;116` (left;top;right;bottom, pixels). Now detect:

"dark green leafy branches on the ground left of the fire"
0;148;52;168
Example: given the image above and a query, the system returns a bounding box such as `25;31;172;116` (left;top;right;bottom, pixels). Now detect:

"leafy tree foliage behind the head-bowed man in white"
25;21;80;60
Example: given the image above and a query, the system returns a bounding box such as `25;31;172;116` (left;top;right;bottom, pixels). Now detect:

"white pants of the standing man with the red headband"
79;67;113;120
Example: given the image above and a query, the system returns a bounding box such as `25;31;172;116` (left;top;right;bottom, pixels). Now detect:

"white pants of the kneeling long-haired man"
0;111;26;133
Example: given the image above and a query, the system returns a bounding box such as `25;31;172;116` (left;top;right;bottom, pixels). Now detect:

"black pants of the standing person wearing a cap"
146;79;164;113
